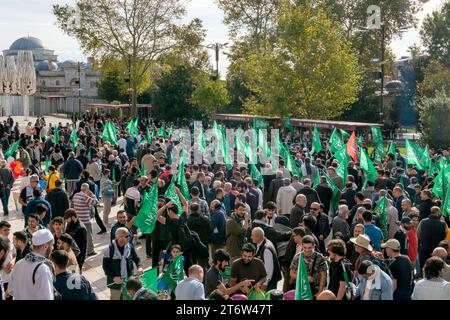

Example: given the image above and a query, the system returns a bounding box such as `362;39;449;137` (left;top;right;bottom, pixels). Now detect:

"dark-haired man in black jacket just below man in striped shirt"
64;209;87;274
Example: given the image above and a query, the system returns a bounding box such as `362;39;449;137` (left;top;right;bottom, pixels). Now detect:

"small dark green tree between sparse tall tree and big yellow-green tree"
152;64;200;121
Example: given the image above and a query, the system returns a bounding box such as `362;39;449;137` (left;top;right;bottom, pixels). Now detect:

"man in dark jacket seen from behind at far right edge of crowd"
417;206;447;268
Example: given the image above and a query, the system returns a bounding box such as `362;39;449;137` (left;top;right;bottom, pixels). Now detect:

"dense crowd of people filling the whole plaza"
0;113;450;300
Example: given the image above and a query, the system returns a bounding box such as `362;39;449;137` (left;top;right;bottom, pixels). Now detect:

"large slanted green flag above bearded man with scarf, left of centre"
134;183;158;234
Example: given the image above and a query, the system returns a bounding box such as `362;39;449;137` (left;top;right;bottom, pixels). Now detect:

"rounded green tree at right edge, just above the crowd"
418;90;450;148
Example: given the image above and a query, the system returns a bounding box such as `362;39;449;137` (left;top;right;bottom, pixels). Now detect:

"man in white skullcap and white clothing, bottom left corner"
8;229;54;300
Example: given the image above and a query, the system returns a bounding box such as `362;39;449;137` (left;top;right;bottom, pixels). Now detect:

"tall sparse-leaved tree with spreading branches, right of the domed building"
53;0;204;114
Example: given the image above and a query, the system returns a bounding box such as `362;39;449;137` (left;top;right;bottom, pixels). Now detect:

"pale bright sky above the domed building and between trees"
0;0;449;76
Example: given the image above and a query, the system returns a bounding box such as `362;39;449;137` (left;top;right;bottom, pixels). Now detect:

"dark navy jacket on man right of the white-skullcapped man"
53;272;98;300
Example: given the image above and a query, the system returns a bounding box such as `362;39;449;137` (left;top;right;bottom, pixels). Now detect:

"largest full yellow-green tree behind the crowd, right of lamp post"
239;0;360;119
